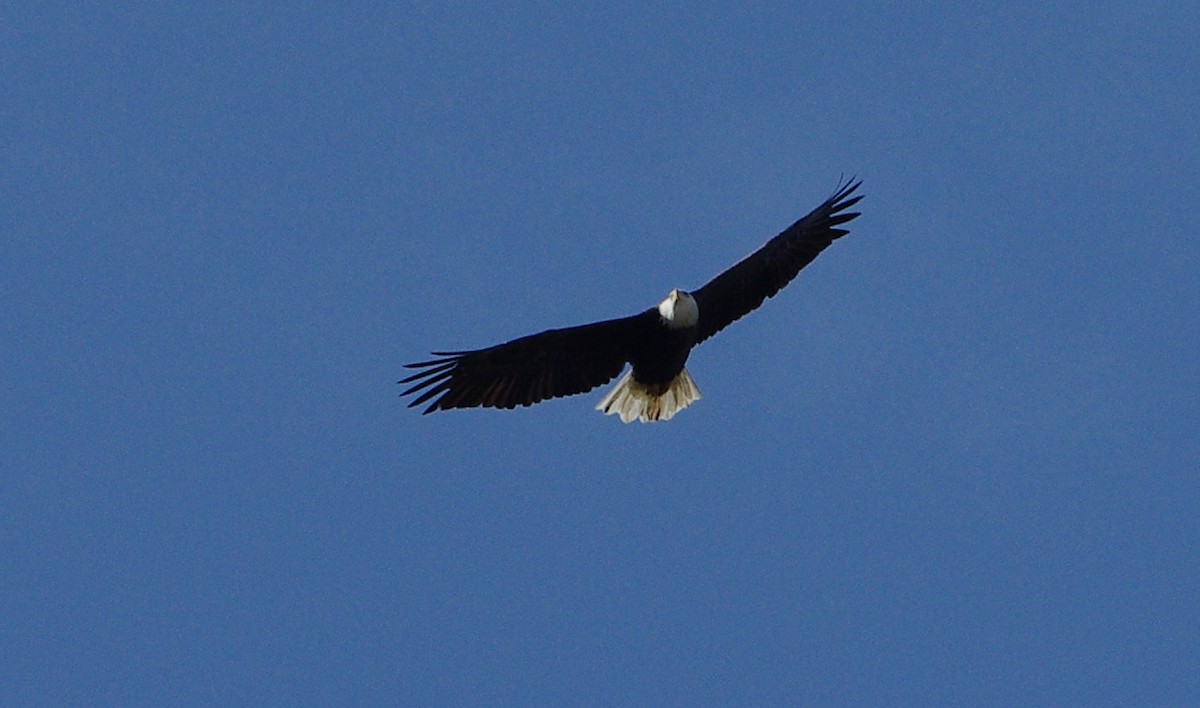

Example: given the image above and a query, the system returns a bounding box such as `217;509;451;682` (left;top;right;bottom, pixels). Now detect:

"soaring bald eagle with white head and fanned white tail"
400;180;863;422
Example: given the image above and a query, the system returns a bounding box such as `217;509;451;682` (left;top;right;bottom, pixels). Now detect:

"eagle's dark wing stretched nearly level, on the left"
400;310;658;413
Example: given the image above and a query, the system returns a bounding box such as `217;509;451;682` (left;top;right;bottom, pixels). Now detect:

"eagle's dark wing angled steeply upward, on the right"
691;179;863;344
